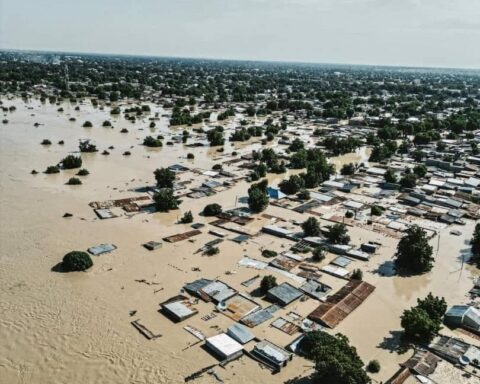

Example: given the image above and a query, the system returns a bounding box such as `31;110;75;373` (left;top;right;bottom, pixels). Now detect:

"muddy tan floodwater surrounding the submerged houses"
0;101;478;384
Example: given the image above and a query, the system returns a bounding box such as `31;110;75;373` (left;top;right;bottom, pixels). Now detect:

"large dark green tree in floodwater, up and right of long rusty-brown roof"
395;225;434;274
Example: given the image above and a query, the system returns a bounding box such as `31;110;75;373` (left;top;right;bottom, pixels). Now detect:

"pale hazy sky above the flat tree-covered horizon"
0;0;480;69
